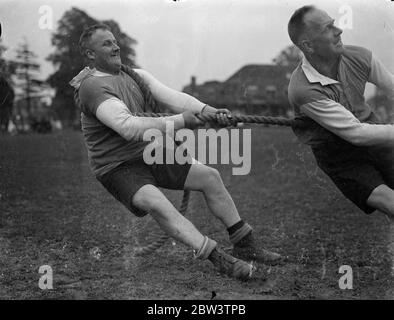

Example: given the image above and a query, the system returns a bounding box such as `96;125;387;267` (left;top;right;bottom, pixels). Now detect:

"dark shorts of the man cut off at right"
312;140;394;214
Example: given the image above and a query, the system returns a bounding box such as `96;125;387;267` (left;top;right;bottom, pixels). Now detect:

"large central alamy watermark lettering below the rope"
143;121;252;175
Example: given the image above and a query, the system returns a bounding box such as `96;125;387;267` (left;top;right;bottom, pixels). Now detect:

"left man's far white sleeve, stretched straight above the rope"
135;69;205;113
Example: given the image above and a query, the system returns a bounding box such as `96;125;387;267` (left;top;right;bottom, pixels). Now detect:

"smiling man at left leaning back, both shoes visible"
71;25;282;280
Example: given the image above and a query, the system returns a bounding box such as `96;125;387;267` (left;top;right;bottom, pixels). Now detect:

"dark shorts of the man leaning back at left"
97;151;191;217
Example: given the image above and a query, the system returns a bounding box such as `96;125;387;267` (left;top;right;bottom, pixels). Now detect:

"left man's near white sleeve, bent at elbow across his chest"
96;97;184;141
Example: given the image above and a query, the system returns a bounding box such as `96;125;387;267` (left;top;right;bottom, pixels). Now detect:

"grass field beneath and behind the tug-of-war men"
0;127;394;299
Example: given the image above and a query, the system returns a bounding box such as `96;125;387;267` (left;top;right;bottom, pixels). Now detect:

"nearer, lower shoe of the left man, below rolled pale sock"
208;247;256;281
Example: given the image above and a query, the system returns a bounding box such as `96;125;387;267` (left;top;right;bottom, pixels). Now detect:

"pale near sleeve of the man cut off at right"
300;99;394;146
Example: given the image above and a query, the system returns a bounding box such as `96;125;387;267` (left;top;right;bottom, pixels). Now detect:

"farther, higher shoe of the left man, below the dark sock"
232;232;286;266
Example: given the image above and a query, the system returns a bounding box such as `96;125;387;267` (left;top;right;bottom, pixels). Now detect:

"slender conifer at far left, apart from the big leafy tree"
14;40;44;117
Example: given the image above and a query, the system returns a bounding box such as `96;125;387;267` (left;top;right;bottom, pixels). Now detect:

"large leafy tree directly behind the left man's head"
47;8;137;126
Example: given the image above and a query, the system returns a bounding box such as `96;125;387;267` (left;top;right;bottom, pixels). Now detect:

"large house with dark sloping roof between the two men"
183;65;293;116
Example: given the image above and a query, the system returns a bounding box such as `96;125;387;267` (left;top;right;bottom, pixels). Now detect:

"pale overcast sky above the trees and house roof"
0;0;394;90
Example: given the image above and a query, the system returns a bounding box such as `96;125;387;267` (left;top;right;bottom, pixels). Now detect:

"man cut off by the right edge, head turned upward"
288;6;394;221
